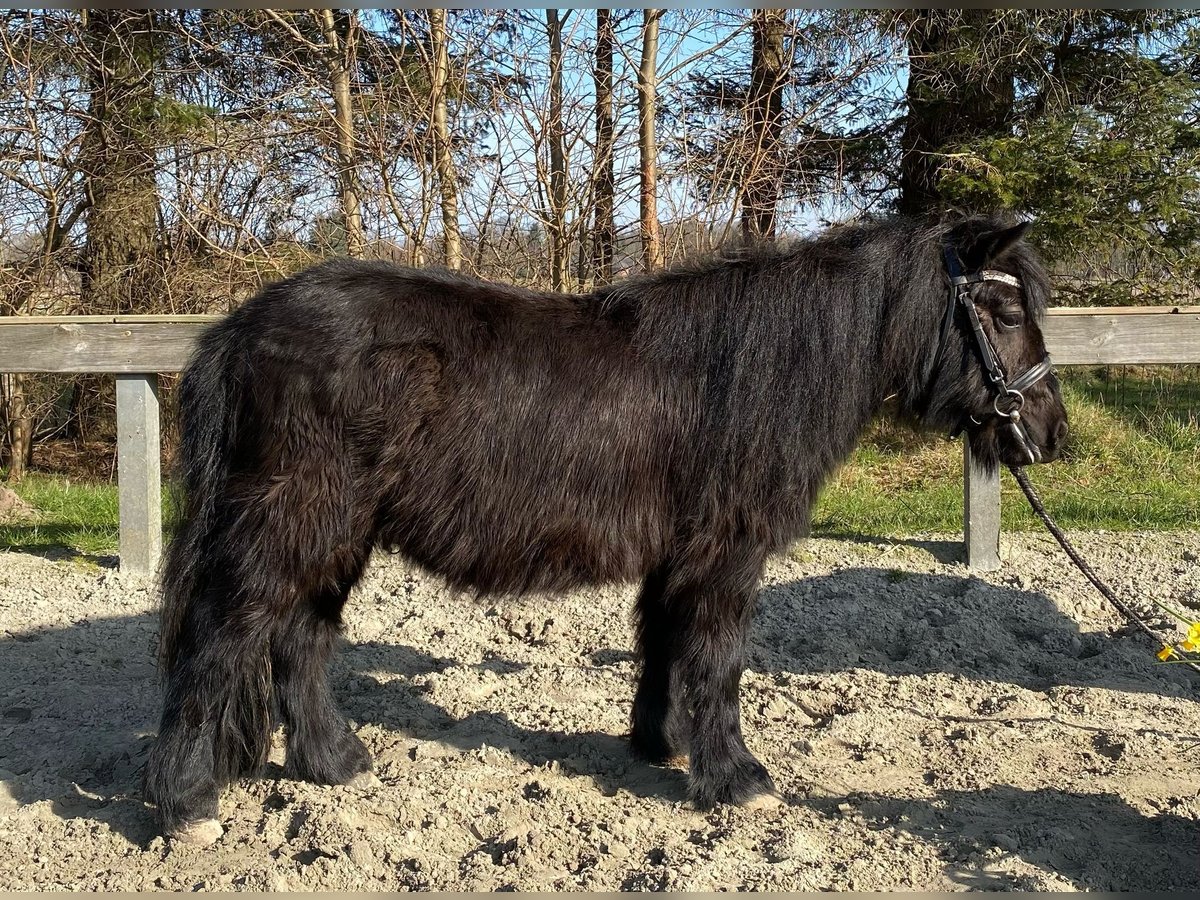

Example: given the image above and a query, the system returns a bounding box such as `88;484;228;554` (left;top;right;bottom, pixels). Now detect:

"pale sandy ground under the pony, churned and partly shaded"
0;533;1200;890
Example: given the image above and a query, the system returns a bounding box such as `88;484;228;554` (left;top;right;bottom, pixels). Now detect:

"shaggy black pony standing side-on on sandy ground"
145;218;1066;842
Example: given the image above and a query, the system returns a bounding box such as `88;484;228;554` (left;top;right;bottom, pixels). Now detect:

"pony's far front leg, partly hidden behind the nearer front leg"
629;566;691;766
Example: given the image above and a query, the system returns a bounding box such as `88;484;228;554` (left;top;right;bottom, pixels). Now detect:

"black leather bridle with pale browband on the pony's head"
929;244;1051;463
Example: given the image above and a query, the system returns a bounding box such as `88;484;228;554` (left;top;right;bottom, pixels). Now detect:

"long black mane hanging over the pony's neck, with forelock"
592;216;1049;508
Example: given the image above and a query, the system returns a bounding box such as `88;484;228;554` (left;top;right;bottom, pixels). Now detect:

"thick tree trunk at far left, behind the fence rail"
82;10;162;313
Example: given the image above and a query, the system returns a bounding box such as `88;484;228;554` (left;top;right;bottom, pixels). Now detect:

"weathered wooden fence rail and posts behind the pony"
0;307;1200;572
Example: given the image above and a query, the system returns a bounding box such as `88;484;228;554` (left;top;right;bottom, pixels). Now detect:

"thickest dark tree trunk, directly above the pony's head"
898;10;1015;217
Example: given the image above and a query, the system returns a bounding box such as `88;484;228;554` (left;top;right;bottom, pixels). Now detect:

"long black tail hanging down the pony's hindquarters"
158;320;244;672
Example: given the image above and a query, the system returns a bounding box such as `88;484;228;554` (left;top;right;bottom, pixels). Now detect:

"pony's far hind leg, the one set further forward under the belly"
271;552;371;785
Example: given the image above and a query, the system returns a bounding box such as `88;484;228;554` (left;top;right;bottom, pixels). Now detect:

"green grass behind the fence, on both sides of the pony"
0;366;1200;556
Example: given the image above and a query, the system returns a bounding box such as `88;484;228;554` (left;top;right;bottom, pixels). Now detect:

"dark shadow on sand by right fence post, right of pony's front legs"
750;568;1195;697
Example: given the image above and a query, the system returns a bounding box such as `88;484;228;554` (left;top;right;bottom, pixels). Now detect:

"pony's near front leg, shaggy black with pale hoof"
667;548;778;809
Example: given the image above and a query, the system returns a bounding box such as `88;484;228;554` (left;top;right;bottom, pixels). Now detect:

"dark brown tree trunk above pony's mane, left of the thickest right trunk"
742;10;788;242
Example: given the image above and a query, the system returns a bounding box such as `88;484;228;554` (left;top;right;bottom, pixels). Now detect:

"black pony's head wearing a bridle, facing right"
922;218;1067;468
